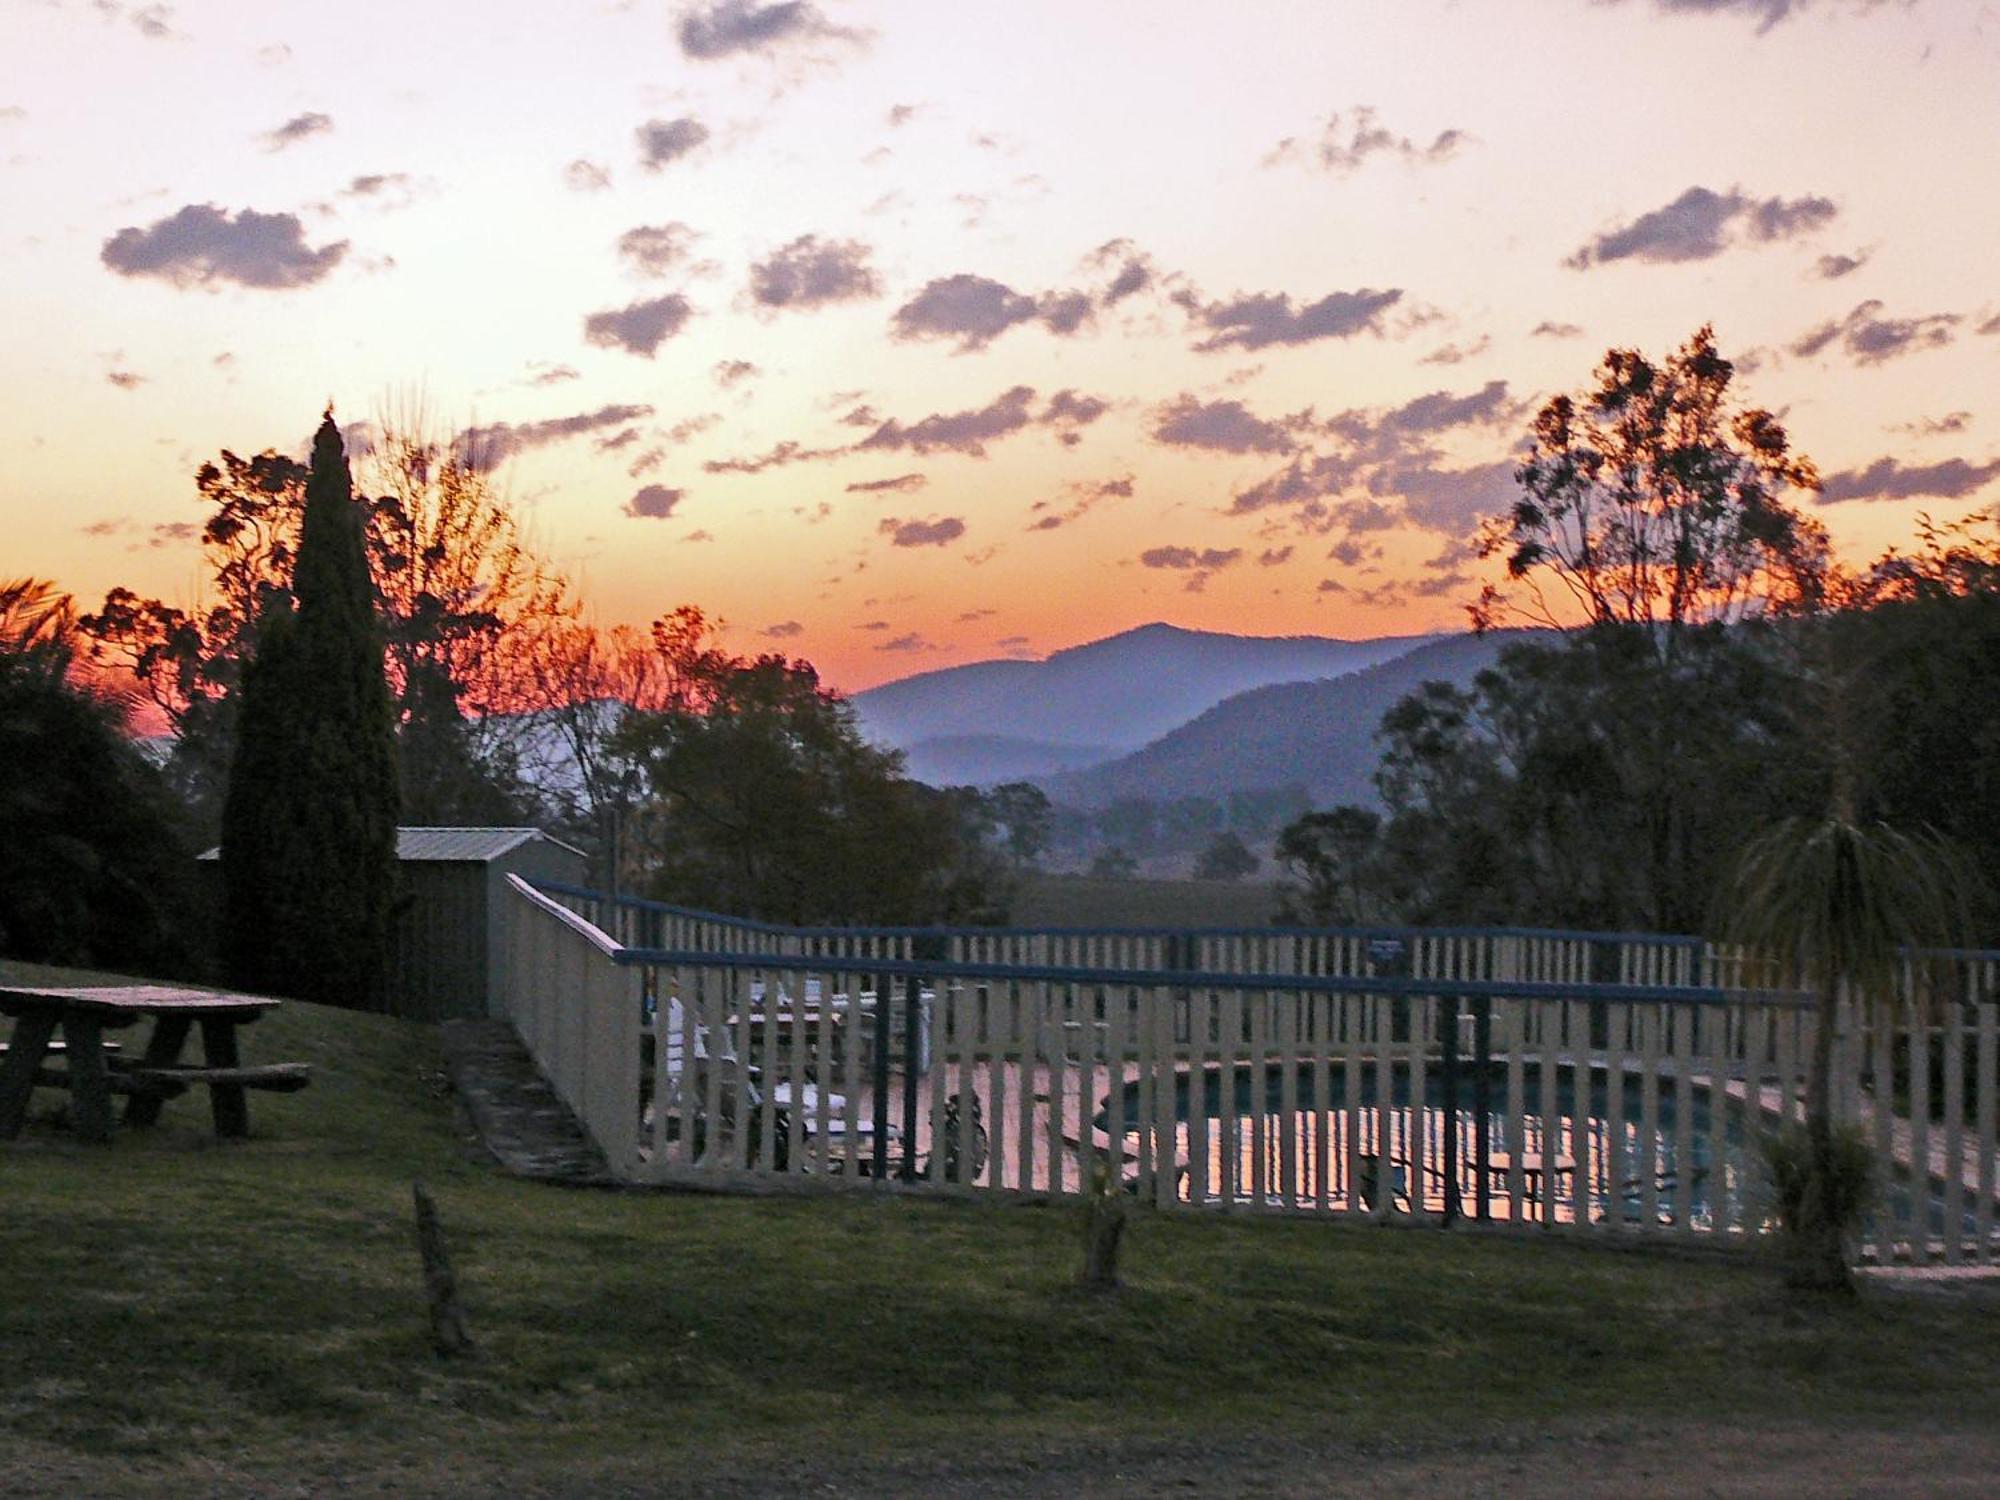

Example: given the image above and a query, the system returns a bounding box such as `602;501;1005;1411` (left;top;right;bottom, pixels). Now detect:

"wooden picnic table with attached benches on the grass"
0;984;312;1140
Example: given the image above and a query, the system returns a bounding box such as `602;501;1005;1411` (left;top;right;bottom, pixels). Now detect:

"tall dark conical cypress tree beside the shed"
222;410;396;1006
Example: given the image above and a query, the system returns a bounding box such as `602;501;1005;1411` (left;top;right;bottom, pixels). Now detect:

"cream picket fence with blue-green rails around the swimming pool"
508;880;2000;1264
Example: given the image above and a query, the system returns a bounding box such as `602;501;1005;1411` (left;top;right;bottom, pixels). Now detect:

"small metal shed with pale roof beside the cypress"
200;828;588;1020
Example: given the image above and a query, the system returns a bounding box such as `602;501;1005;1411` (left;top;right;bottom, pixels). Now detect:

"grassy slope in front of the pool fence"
0;966;2000;1492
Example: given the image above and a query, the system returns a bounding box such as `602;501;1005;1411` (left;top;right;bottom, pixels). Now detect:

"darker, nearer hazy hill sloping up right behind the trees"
1042;630;1528;824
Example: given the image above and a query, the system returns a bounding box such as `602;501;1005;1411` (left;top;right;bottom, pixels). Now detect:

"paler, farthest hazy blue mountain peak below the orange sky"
854;624;1432;754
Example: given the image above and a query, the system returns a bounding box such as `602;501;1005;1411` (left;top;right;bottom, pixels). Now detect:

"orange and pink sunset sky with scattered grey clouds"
0;0;2000;688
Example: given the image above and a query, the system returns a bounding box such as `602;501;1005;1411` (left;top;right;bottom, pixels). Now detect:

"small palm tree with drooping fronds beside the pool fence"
1722;816;1970;1290
